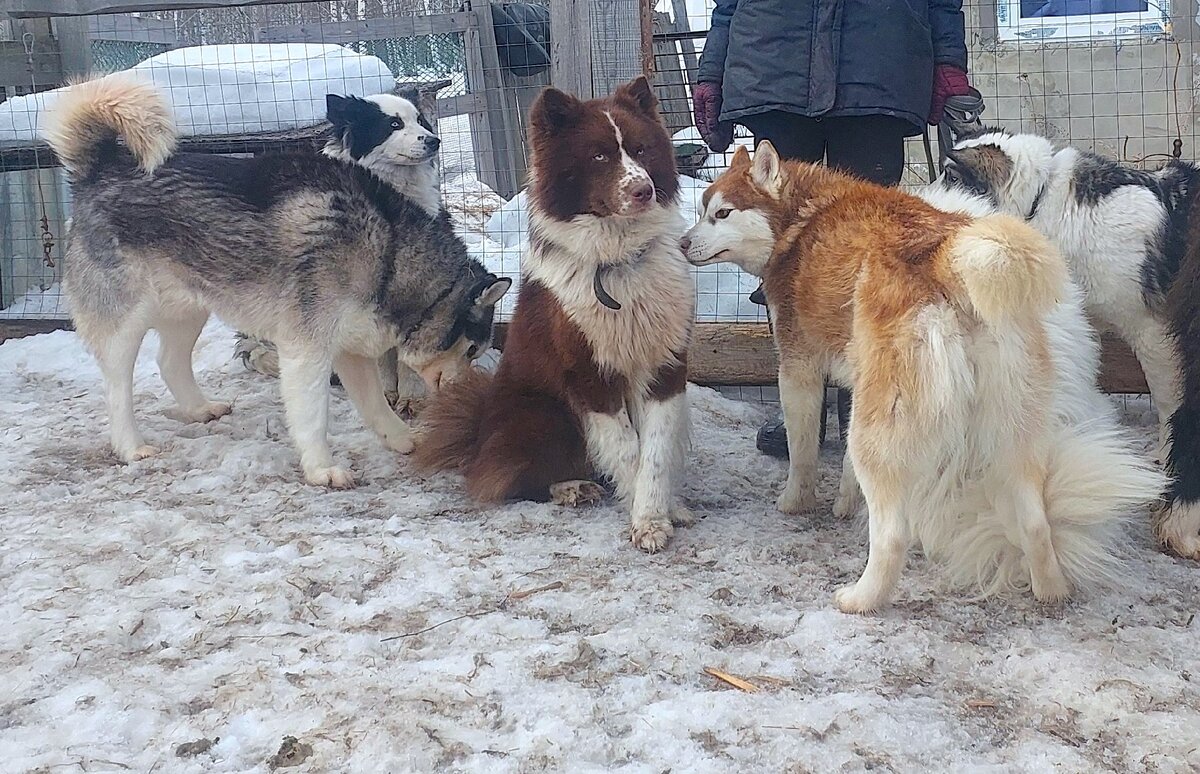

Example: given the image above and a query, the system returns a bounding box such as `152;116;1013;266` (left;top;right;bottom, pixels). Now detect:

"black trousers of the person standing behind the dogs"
740;110;912;443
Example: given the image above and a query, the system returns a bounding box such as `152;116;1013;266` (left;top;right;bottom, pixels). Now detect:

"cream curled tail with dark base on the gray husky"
42;74;178;178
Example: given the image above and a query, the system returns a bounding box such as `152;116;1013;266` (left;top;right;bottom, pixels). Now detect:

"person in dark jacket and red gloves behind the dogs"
692;0;971;457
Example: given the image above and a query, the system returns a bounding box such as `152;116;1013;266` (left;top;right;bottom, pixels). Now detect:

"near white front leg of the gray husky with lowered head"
278;346;348;490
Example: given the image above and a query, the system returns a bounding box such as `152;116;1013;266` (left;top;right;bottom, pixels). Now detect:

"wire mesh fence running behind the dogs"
0;0;1180;410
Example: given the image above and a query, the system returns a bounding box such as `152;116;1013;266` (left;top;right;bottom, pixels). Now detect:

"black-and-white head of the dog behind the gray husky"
325;94;442;166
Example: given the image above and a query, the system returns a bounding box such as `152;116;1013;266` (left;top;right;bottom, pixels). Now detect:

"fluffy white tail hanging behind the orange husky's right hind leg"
940;420;1166;595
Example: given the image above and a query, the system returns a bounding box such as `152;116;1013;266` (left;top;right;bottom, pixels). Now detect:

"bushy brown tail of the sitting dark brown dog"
413;368;492;472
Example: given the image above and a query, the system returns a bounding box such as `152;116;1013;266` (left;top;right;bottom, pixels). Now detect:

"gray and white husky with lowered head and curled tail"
42;76;511;487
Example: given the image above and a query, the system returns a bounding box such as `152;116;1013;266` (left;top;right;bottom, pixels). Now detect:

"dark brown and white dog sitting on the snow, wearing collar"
415;78;695;551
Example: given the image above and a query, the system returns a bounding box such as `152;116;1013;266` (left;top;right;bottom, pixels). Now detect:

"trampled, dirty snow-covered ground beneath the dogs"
0;325;1200;773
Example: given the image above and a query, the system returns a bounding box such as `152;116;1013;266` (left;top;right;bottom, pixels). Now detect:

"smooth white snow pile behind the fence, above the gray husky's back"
0;43;396;140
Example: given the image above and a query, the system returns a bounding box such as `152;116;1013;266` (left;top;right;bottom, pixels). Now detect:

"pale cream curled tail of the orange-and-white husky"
950;215;1068;325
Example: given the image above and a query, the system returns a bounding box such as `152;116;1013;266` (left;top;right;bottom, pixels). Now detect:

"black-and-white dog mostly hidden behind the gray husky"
234;89;442;408
